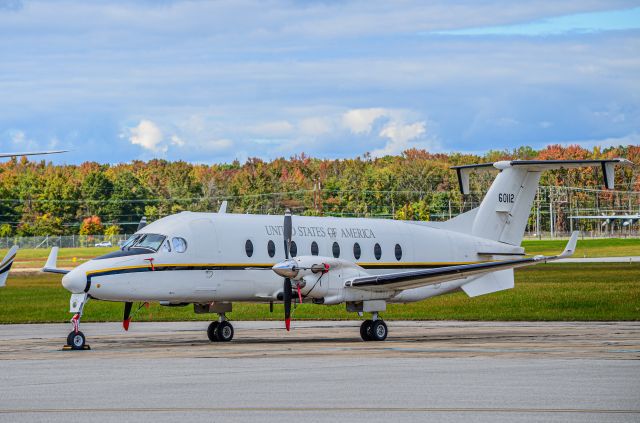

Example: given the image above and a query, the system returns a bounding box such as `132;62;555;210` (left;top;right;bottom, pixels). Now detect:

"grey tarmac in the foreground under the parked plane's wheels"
0;321;640;422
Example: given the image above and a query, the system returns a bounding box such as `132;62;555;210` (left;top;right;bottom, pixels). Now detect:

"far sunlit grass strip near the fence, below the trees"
0;238;640;269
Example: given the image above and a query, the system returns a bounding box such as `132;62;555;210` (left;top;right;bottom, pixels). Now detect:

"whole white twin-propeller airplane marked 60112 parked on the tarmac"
43;159;631;349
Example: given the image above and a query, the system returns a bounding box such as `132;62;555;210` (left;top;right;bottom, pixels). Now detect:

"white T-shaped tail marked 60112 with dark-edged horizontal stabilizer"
453;159;632;245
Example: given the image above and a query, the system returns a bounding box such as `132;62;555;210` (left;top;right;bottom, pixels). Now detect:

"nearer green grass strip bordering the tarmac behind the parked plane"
0;263;640;323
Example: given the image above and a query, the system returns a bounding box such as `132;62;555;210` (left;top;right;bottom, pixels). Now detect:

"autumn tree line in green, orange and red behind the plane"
0;145;640;236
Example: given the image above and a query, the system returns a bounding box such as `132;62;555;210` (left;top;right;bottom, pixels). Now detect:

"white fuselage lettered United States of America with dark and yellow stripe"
63;212;521;304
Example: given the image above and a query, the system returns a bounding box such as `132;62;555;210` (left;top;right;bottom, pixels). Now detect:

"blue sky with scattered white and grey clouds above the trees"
0;0;640;163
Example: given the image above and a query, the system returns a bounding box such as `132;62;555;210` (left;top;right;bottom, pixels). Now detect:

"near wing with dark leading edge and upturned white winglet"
344;231;578;291
